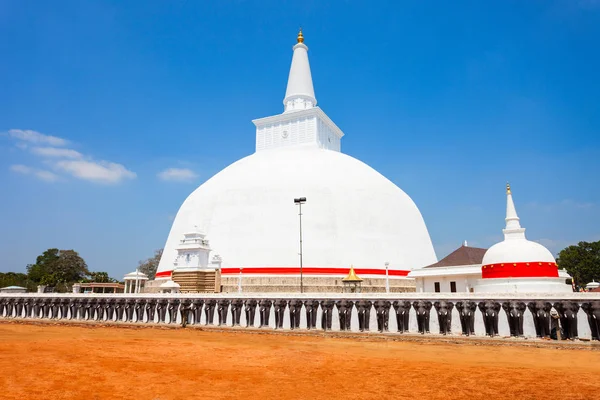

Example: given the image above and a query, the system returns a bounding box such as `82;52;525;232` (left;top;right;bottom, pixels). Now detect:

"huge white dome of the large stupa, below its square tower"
159;145;437;272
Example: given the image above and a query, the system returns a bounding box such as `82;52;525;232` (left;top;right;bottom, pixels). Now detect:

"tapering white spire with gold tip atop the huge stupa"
283;29;317;112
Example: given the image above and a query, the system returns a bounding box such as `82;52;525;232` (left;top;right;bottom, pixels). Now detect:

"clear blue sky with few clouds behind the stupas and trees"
0;0;600;278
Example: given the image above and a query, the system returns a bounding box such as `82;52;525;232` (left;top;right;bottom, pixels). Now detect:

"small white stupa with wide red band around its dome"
475;184;573;293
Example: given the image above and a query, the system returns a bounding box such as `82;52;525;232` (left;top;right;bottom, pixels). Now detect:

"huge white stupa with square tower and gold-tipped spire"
156;32;437;279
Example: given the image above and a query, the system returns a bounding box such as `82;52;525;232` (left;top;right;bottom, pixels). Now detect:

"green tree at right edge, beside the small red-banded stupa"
556;241;600;287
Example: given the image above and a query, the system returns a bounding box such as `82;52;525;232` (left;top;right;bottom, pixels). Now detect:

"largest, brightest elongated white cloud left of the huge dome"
55;160;137;183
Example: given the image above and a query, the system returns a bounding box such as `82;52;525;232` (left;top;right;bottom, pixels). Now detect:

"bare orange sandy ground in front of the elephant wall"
0;323;600;400
